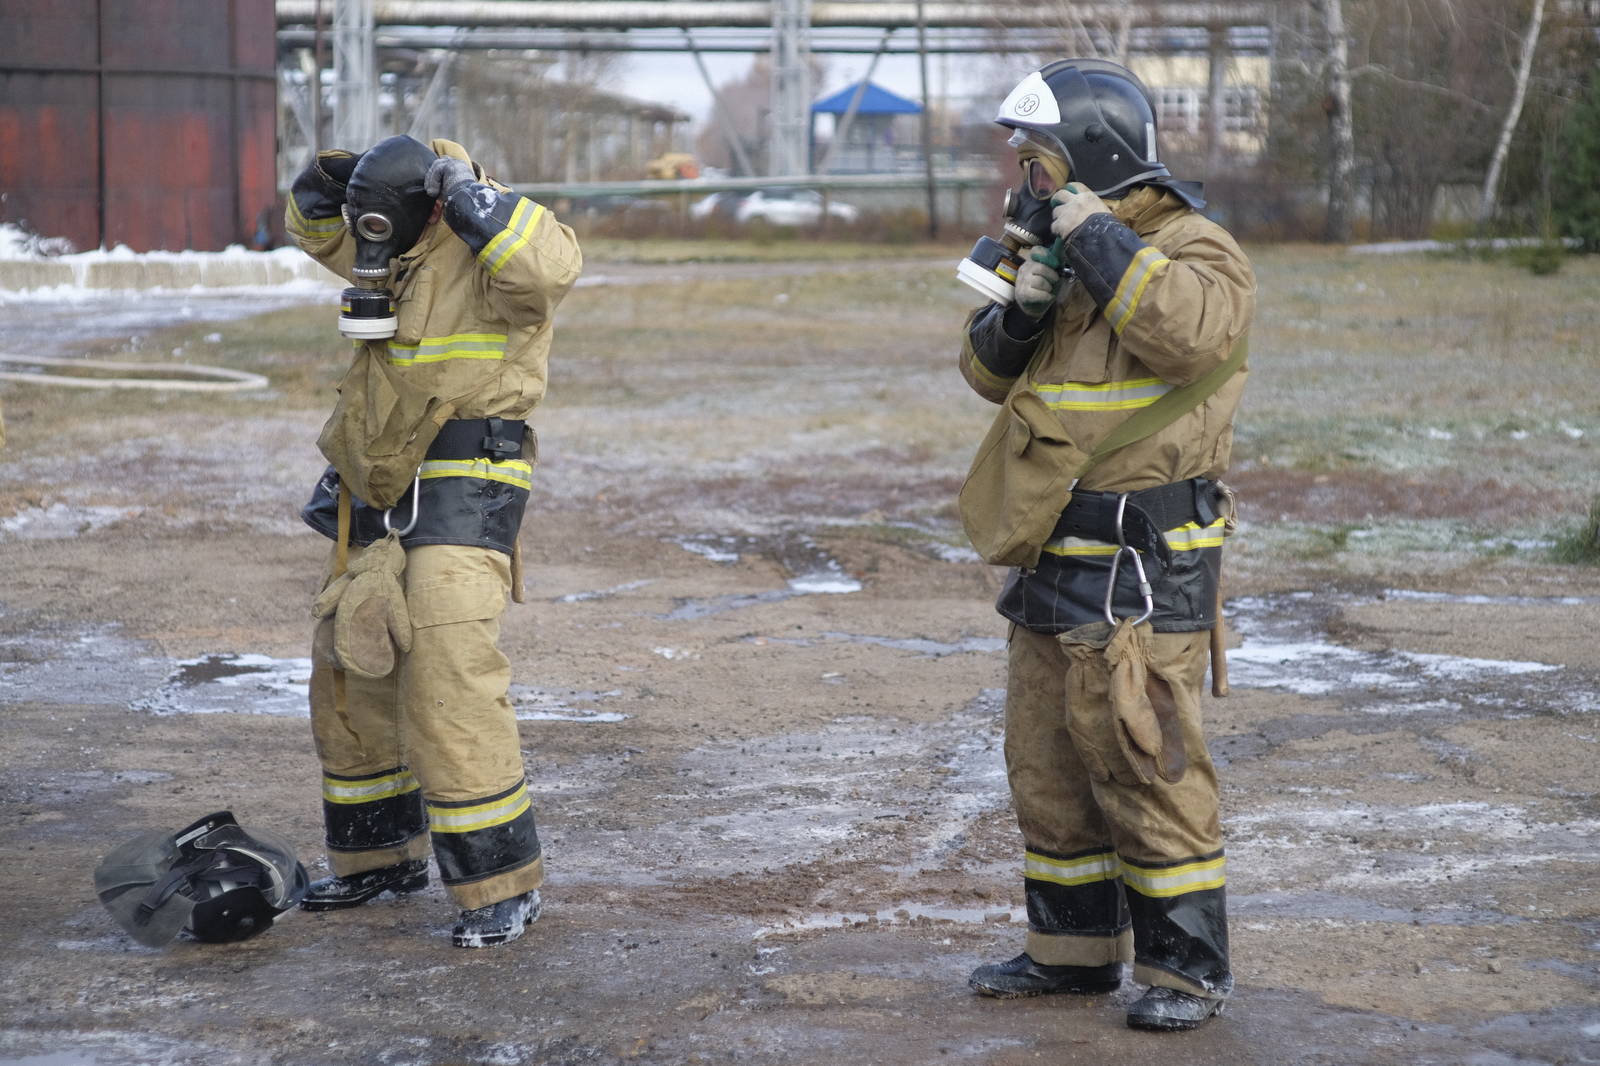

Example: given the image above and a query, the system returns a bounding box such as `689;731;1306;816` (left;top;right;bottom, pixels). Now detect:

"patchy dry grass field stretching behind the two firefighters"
0;242;1600;570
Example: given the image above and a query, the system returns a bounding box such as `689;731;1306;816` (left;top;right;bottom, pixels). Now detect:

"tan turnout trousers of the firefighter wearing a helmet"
1005;626;1232;999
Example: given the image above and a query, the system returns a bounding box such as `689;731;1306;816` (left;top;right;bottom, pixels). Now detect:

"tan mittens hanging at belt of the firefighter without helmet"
310;533;411;679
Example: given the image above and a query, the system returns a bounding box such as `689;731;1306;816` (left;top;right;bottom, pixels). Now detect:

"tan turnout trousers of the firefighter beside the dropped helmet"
310;544;544;909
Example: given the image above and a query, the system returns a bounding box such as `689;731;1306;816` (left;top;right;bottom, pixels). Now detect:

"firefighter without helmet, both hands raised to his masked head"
286;136;582;948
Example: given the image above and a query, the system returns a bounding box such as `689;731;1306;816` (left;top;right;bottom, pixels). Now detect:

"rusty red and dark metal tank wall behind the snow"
0;0;277;251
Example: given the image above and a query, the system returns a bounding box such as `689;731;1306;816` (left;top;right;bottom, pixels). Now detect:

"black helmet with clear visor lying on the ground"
94;810;309;948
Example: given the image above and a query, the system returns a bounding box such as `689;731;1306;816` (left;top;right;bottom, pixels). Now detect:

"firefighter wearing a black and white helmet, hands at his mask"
960;59;1254;1029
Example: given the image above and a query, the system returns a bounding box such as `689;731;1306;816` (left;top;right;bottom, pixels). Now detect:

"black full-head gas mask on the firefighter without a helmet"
339;136;438;339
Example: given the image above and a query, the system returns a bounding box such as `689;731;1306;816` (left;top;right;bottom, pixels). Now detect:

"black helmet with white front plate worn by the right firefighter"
995;59;1171;197
